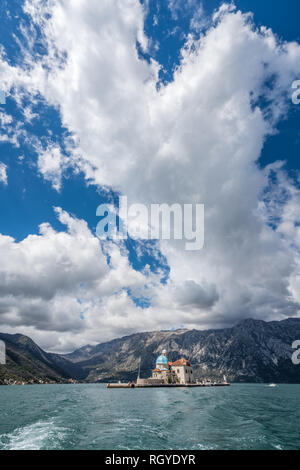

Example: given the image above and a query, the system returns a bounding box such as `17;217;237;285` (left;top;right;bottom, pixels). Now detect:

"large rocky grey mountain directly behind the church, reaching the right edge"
65;318;300;383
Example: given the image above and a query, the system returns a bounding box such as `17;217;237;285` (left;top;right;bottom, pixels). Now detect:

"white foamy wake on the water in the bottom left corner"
0;420;67;450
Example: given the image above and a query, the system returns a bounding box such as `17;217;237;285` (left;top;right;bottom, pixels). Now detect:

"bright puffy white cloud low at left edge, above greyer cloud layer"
0;209;106;300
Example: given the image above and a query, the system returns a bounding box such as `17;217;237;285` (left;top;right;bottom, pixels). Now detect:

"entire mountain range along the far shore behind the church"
0;318;300;384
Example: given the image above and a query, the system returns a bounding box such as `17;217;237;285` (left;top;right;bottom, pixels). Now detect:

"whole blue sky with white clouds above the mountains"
0;0;300;352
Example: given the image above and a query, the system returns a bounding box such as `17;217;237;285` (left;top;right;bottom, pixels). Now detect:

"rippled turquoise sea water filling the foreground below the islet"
0;384;300;450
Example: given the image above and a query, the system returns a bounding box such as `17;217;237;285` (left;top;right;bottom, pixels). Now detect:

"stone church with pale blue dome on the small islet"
136;349;196;386
